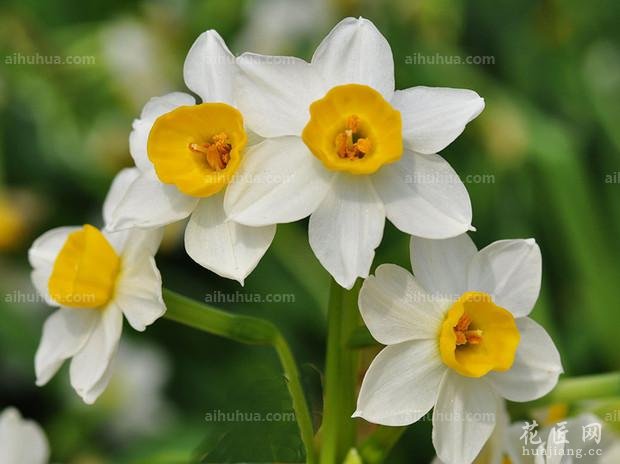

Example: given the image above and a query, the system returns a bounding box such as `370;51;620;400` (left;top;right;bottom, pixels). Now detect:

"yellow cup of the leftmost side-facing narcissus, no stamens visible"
48;225;121;308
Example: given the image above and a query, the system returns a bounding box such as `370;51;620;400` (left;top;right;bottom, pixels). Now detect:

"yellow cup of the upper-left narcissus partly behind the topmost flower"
147;103;247;198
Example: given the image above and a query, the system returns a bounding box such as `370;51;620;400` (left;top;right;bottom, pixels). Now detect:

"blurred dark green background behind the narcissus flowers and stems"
0;0;620;464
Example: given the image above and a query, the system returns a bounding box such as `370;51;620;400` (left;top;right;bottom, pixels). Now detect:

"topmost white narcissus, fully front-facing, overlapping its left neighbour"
224;18;484;288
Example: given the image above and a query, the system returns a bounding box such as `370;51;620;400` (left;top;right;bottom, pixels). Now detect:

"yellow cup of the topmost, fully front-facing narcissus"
301;84;403;174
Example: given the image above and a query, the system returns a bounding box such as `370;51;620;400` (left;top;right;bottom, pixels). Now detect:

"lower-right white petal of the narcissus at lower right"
486;317;563;401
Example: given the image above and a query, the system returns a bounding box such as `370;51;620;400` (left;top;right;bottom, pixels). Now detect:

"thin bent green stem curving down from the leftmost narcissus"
163;289;316;464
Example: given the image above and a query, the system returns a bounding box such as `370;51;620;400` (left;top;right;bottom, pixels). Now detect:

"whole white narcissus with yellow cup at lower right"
355;234;562;464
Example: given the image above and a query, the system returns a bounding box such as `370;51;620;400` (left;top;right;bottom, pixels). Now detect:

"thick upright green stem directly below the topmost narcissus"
320;280;359;464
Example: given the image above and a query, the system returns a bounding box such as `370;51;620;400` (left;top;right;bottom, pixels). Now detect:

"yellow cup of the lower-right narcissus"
439;292;520;377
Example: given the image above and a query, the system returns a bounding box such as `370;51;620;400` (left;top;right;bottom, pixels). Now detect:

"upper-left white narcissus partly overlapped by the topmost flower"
109;30;276;284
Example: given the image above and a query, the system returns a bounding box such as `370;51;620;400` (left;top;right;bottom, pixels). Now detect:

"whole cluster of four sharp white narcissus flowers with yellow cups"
21;14;576;464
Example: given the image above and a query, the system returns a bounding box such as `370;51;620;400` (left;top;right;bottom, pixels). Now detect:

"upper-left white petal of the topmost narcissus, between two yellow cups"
235;53;328;137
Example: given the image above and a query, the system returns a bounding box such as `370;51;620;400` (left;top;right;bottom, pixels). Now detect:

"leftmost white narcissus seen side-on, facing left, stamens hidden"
29;170;166;404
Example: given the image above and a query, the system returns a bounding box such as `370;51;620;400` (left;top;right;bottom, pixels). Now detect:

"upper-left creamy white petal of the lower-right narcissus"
359;264;444;345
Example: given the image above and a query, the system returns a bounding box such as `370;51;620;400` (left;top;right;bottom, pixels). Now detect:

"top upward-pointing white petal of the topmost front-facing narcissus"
312;18;394;101
